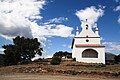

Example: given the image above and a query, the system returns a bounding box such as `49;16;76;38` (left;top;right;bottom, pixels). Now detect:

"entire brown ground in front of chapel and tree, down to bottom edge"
0;63;120;80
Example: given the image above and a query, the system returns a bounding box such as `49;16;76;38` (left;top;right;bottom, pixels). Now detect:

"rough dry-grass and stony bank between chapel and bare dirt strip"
0;62;120;80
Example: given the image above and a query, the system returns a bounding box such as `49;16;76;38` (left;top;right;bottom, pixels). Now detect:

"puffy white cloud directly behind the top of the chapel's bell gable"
75;6;104;27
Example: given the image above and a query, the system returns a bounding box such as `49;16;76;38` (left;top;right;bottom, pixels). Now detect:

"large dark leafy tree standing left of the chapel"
3;36;43;65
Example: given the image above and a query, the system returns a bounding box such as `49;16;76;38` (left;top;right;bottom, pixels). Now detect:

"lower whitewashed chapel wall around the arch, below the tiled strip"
72;47;105;64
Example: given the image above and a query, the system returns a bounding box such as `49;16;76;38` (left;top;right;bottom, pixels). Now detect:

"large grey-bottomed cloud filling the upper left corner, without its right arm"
0;0;45;39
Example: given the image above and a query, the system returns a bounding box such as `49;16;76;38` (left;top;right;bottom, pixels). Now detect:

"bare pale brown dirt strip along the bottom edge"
0;73;119;80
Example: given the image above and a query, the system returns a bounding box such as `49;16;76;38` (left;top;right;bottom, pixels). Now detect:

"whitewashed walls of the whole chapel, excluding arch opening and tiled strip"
72;21;105;64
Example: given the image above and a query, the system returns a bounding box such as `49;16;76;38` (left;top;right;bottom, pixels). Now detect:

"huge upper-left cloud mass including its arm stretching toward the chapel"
0;0;73;43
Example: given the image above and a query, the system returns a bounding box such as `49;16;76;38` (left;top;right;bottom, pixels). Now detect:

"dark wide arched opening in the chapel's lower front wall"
82;49;98;58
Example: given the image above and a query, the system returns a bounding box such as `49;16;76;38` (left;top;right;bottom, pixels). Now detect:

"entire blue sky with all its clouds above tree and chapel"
0;0;120;57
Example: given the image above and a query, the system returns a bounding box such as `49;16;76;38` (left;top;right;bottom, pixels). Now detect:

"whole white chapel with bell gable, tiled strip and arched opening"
72;20;105;64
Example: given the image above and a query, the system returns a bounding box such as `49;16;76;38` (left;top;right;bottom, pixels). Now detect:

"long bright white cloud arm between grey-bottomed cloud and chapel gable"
31;23;74;38
